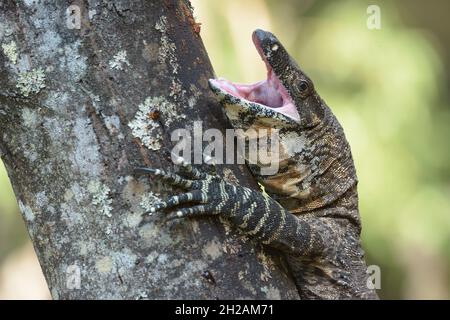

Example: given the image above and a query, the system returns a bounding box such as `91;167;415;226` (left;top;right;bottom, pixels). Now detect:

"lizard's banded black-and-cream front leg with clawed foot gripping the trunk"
134;165;327;254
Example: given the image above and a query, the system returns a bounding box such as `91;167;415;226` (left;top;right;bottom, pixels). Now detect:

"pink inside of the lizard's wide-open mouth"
210;33;300;121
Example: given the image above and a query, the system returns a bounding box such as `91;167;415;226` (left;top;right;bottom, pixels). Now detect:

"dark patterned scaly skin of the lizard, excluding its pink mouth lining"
138;30;378;299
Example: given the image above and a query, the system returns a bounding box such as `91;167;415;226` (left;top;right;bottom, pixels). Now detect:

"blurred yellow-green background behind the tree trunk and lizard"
0;0;450;299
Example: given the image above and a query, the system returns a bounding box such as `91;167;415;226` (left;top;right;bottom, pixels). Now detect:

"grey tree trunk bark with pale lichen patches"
0;0;298;299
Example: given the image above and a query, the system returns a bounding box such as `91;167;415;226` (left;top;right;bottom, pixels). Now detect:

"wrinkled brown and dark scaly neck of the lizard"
254;107;358;219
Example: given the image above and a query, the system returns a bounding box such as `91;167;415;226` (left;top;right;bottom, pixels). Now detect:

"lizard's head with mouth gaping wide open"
209;29;324;129
